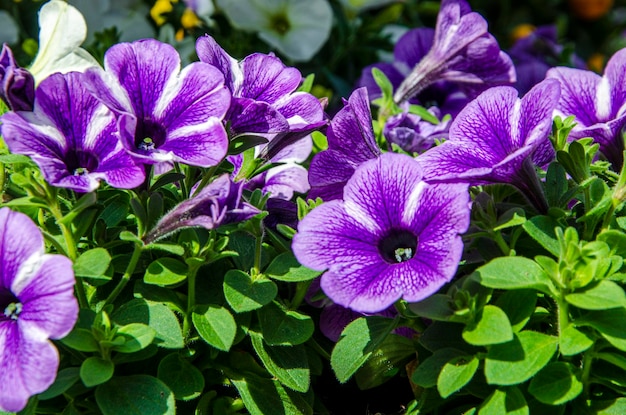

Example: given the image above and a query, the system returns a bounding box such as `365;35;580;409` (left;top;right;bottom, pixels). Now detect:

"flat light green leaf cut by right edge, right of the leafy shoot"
565;280;626;310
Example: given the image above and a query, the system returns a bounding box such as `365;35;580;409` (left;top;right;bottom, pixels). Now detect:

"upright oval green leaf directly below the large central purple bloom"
330;316;396;383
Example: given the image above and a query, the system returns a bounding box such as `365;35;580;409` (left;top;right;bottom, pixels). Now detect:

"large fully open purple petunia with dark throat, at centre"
293;153;470;313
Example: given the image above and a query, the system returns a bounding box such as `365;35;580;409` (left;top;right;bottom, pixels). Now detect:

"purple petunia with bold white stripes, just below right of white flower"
87;39;230;171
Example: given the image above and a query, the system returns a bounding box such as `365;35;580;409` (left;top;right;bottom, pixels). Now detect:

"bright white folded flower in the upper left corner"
29;0;99;83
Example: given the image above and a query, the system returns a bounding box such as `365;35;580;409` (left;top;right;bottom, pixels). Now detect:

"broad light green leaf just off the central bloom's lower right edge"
475;257;555;295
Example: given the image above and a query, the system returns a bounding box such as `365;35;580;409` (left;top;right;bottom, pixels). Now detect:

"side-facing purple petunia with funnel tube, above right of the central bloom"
418;80;560;212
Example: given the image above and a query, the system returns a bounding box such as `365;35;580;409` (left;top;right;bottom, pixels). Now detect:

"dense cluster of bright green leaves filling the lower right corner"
331;118;626;414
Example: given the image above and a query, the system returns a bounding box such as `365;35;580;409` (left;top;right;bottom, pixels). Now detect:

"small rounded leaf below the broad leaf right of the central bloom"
463;304;513;346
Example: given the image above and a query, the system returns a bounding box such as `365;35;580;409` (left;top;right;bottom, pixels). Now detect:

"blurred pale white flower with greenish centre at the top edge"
217;0;333;61
